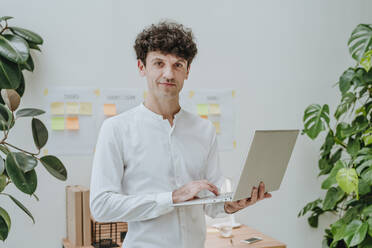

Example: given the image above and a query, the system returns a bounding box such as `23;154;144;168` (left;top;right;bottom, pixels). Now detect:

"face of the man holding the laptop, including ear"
138;51;190;99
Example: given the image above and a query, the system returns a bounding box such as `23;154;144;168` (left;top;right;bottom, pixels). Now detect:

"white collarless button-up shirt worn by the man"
90;104;225;248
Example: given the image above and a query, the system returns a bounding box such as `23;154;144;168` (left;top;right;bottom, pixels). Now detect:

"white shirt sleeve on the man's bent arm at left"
90;118;173;222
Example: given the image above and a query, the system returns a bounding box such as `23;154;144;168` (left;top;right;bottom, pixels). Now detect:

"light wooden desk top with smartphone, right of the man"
205;225;287;248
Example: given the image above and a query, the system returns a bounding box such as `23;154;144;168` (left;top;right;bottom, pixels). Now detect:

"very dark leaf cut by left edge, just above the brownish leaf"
0;56;22;89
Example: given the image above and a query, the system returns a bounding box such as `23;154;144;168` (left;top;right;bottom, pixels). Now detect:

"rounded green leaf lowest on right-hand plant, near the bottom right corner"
344;220;368;247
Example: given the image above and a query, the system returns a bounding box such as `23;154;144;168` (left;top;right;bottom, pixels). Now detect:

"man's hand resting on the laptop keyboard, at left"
172;180;219;203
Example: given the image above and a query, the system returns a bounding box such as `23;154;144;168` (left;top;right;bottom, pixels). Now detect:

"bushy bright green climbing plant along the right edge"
298;24;372;248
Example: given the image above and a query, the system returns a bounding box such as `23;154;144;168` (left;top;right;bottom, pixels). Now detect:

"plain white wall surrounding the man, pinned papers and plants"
0;0;372;248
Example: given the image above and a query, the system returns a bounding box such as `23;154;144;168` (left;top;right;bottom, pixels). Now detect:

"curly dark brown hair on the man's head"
134;21;198;67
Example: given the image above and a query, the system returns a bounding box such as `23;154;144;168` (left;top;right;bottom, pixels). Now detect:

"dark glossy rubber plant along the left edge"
0;16;67;241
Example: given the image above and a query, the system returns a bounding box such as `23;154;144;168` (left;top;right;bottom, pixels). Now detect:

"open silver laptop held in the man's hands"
173;130;299;207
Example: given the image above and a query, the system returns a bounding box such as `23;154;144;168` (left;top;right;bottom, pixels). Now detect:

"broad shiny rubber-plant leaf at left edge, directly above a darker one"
0;34;30;64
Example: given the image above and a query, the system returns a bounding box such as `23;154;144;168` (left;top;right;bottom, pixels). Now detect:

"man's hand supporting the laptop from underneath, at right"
225;182;271;214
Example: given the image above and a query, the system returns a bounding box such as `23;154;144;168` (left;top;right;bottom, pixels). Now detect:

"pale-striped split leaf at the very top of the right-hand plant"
348;24;372;63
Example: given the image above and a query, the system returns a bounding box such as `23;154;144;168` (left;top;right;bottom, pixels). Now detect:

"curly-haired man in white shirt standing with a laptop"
90;22;271;248
